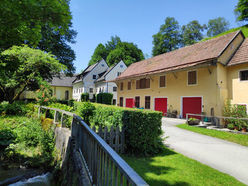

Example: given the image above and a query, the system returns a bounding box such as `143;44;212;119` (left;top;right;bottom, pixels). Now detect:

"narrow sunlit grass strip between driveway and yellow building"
177;124;248;146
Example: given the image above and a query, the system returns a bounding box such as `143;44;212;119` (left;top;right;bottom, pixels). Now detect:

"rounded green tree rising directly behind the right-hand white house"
107;42;144;66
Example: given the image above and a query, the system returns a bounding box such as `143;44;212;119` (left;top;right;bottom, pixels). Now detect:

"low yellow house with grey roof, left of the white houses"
20;75;75;100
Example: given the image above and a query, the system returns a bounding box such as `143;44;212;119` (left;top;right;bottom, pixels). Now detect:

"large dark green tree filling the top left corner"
0;0;75;72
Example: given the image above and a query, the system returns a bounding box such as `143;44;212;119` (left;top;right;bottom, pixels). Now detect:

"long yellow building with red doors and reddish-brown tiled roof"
115;31;248;118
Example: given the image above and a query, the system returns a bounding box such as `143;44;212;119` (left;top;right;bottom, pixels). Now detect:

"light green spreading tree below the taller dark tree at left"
0;45;66;103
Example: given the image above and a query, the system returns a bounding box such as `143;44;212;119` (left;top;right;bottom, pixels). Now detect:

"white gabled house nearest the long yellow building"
95;61;127;105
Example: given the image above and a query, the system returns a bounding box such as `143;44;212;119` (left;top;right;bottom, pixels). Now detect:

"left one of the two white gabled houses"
72;60;109;101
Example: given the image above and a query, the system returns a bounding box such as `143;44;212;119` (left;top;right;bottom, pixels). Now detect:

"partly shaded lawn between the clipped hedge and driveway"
123;148;244;186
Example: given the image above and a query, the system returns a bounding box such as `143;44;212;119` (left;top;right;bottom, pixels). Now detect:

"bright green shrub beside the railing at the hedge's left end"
77;102;96;125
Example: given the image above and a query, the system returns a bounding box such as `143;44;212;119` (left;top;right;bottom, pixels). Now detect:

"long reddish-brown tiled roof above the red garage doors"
116;31;242;80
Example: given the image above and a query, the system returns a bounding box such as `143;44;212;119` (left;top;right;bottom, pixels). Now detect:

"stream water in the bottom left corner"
10;173;52;186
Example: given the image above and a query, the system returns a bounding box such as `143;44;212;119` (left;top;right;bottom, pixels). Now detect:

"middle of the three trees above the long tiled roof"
182;20;205;46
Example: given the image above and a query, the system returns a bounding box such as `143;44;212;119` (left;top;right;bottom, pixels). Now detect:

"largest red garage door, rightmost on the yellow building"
183;97;202;118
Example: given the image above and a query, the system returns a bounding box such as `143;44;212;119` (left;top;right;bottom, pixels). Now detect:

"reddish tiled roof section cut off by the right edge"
227;38;248;66
